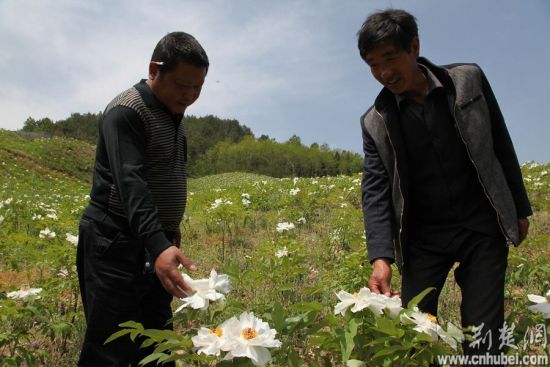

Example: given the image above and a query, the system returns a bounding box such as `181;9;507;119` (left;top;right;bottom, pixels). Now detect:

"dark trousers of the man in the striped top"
77;215;175;367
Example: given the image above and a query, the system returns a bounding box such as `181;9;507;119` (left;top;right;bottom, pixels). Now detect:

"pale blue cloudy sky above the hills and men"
0;0;550;162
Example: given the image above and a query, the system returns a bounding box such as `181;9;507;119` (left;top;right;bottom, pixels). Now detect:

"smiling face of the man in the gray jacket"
366;38;419;94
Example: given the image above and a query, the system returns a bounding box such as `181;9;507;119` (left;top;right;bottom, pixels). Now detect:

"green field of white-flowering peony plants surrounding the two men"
0;130;550;367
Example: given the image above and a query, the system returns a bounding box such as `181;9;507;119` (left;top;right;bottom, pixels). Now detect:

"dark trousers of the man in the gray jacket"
401;229;508;366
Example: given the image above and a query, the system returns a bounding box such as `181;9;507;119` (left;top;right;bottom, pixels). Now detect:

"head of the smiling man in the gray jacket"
357;9;422;94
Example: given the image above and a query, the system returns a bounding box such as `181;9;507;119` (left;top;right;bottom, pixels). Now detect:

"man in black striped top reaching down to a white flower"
77;32;209;367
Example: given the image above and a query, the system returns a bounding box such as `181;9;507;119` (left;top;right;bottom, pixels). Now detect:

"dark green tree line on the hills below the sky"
22;112;362;177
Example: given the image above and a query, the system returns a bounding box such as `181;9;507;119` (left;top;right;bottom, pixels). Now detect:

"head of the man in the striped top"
147;32;209;113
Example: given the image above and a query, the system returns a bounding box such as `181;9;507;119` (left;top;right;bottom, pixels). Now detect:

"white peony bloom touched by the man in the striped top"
175;269;231;312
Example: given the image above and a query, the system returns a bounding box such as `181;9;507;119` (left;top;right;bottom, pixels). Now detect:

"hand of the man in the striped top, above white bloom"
155;246;197;298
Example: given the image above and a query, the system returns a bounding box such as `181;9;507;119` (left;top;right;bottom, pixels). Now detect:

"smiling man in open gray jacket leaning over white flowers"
358;9;532;362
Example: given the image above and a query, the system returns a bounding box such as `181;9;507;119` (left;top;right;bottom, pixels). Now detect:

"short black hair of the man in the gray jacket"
357;9;418;61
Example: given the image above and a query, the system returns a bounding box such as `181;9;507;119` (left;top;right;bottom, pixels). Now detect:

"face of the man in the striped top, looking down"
148;62;207;113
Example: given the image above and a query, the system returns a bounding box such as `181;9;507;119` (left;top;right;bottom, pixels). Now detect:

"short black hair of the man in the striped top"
151;32;210;74
